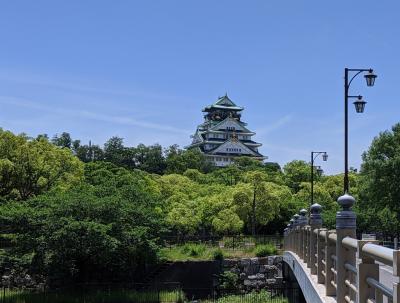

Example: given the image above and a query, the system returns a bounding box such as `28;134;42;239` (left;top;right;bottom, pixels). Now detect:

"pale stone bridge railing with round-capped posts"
284;194;400;303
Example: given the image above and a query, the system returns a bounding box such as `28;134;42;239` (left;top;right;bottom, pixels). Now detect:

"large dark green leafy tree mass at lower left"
0;163;164;281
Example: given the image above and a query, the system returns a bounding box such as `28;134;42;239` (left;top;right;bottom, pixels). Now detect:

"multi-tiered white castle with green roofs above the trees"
186;95;265;166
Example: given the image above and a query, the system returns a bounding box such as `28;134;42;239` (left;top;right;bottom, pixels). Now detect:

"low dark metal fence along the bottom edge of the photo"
0;287;304;303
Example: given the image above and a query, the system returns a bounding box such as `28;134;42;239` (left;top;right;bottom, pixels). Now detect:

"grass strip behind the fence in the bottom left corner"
0;290;185;303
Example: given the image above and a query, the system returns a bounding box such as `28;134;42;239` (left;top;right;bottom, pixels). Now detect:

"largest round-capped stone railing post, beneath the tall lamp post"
336;193;356;303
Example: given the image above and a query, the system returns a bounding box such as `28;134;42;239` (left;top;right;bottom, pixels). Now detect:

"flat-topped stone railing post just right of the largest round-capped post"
357;240;378;302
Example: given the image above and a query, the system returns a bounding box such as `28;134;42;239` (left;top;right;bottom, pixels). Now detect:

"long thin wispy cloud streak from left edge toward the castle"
0;96;190;135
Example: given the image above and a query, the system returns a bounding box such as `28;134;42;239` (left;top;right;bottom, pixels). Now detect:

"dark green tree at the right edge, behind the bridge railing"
359;124;400;236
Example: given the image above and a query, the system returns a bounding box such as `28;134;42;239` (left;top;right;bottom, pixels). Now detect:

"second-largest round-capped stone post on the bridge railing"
308;203;322;275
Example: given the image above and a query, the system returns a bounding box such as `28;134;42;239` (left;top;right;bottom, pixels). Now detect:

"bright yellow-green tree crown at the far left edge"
0;129;83;200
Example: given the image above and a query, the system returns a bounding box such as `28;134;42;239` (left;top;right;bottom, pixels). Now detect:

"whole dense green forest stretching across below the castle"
0;124;400;283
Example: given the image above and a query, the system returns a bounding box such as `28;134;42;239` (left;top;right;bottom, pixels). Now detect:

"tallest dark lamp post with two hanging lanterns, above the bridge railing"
343;68;377;194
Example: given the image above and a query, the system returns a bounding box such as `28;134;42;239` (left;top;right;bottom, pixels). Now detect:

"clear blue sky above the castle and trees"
0;0;400;173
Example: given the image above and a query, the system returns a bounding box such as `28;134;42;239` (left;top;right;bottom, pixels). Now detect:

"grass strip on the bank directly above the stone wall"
161;243;278;261
